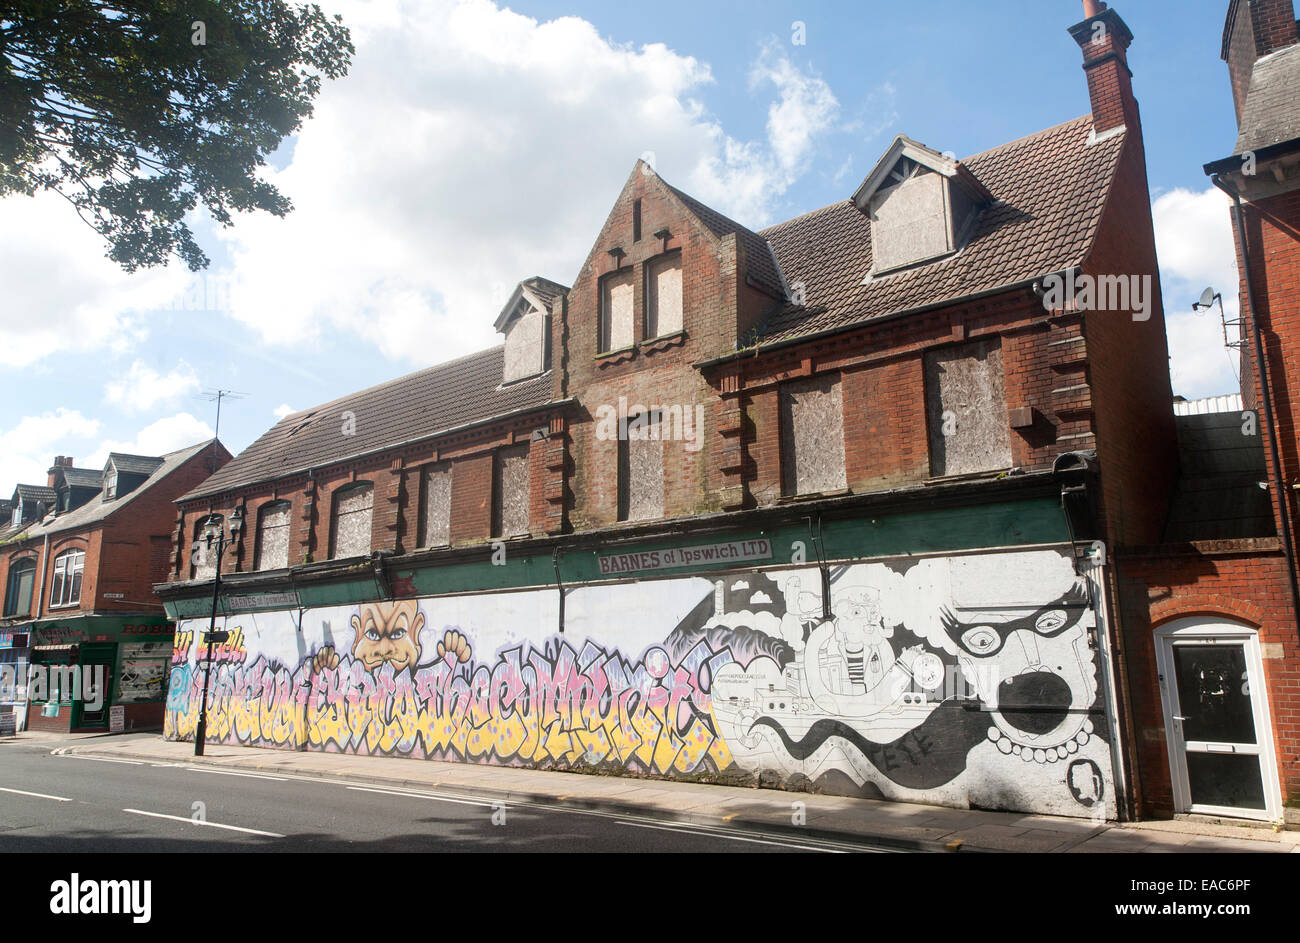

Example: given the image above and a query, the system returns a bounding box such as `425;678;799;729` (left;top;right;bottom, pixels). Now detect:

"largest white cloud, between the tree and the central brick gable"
221;0;837;363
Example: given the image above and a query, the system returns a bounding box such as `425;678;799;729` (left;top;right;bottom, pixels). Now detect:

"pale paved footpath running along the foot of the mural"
12;731;1300;853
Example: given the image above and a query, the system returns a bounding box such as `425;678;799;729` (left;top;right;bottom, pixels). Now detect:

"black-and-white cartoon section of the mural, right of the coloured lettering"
705;551;1113;814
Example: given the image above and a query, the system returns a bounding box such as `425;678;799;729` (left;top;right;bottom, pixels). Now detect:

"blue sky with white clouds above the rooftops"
0;0;1238;496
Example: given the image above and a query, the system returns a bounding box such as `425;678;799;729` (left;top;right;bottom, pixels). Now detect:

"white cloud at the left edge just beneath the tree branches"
0;193;187;367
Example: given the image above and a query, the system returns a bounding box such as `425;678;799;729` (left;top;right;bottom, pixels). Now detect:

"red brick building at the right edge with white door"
1119;0;1300;822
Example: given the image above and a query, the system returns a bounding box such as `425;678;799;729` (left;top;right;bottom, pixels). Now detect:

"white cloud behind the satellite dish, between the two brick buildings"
1152;187;1240;399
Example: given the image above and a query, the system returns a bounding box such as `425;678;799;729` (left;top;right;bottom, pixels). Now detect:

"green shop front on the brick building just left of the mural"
23;614;172;732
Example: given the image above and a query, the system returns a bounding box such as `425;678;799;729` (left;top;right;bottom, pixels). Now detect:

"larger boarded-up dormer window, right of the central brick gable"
853;135;993;277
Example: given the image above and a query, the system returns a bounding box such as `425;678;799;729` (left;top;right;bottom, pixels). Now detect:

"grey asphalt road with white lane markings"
0;743;892;853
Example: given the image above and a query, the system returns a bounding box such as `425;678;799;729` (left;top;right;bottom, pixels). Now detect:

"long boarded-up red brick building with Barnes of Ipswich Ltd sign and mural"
157;3;1196;818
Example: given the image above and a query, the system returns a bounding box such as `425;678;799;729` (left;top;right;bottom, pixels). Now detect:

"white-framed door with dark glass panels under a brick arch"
1156;617;1282;821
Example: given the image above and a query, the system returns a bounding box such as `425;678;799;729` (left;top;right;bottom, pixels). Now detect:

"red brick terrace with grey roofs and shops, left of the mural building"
0;440;230;731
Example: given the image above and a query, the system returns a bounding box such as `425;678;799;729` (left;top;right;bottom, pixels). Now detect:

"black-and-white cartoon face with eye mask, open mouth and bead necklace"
943;584;1097;762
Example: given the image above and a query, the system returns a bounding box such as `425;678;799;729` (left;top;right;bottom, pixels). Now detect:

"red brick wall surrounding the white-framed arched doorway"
1118;549;1300;816
